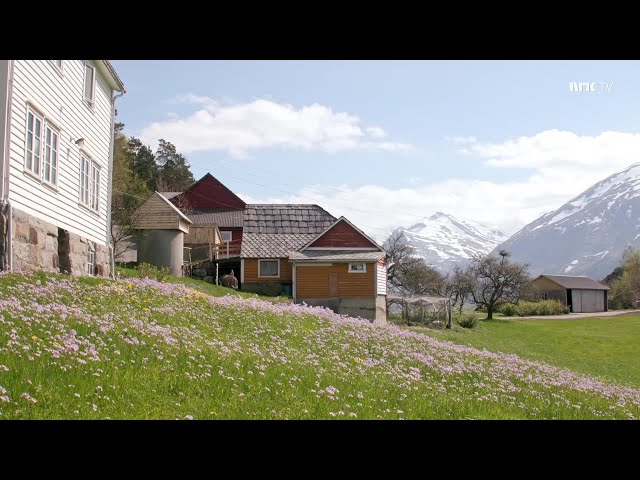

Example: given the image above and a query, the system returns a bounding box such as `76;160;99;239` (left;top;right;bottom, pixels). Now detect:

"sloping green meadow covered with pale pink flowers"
0;273;640;420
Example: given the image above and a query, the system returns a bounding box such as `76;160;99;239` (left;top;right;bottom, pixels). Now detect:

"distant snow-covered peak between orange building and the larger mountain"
394;212;507;272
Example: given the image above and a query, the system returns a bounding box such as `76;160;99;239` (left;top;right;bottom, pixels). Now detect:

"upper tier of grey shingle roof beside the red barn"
243;204;336;234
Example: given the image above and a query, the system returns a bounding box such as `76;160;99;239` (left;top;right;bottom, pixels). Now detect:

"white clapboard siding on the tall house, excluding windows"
9;60;111;245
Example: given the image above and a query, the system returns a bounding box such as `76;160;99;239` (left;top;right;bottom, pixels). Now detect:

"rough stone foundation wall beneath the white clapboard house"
12;209;111;276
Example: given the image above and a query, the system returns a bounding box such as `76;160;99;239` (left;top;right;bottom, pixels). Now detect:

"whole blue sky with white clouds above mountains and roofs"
113;60;640;239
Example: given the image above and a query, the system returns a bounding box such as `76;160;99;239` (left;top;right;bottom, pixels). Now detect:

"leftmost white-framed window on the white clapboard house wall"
24;107;60;187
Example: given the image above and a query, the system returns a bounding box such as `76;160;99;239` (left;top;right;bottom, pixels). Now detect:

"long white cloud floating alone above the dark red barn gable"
138;94;412;157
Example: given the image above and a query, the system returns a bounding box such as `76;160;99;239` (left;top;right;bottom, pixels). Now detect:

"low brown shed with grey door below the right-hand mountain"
533;274;609;313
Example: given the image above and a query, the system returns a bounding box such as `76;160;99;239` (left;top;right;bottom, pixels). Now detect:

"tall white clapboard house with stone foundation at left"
0;60;124;275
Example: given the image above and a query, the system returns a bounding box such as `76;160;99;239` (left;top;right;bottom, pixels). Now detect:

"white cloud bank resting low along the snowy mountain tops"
238;130;640;241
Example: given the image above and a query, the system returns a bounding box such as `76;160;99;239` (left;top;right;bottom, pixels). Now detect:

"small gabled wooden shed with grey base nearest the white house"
134;192;192;276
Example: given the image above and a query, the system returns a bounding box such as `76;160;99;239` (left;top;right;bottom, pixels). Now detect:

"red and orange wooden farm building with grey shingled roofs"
142;173;387;321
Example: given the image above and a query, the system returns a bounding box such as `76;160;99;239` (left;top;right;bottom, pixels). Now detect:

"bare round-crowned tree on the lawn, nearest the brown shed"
467;250;531;320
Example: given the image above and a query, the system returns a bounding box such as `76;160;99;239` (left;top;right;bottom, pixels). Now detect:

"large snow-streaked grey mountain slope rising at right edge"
494;163;640;280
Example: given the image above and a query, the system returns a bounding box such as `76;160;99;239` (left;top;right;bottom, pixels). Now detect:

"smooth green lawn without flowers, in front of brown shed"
412;316;640;388
